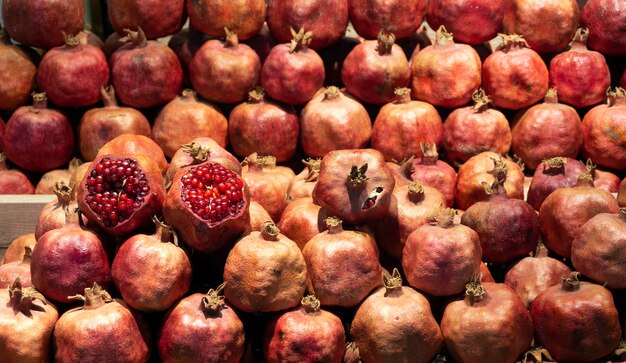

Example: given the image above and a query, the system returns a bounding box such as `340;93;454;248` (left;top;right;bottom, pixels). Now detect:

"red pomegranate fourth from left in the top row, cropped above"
267;0;348;50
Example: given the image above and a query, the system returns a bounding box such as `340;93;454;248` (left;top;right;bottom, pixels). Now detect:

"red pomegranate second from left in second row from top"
37;35;110;107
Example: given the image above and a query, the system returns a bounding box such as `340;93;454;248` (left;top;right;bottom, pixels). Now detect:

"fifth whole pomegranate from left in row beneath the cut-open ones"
402;209;482;296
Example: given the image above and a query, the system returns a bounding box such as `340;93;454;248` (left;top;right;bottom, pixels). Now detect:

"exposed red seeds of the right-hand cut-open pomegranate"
181;163;245;223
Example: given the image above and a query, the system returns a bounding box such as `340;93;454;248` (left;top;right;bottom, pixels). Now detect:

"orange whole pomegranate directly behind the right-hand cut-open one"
152;89;228;158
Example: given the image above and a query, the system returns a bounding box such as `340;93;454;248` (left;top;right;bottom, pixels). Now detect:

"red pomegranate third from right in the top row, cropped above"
427;0;505;44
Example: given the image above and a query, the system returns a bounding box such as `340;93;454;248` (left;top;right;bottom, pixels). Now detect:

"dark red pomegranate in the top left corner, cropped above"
2;0;85;49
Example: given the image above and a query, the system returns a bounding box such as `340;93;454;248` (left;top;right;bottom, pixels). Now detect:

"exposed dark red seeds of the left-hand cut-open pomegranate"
85;158;150;226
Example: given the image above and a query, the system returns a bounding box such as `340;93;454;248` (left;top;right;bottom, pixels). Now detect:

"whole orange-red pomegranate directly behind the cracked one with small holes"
300;86;372;158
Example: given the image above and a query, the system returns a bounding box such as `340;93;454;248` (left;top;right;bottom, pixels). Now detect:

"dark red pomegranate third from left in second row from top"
109;27;183;108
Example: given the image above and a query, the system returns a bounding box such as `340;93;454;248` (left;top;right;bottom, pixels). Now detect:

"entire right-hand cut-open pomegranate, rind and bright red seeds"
163;159;250;252
